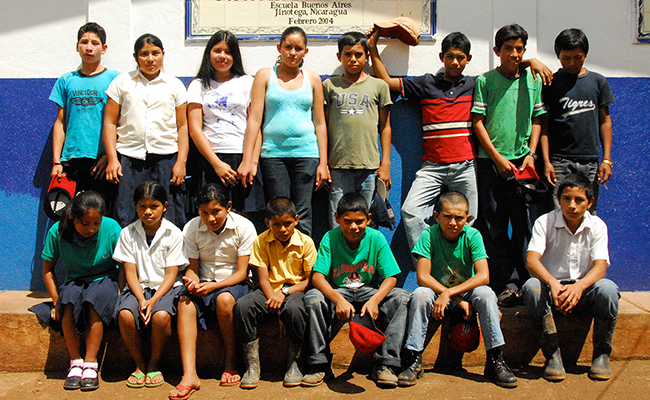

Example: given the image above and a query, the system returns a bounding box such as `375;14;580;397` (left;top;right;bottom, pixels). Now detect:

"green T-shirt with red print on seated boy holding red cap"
313;227;400;289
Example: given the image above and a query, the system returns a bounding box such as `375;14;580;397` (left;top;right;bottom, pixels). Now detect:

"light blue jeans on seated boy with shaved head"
404;286;505;352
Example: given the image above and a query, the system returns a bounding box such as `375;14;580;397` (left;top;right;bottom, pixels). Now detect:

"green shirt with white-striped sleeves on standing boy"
472;69;546;160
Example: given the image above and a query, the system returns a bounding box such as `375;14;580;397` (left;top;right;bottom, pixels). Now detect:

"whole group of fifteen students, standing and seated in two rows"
43;18;619;400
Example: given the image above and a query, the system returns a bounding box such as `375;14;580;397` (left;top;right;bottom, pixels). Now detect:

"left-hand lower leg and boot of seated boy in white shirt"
522;278;566;382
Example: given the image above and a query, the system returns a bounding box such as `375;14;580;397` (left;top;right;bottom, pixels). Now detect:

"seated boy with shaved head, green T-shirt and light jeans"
398;192;517;387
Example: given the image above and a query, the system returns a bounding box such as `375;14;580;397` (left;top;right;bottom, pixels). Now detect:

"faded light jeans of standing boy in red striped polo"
402;160;478;250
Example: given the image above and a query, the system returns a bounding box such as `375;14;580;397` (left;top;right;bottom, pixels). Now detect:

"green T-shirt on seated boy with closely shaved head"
411;224;487;287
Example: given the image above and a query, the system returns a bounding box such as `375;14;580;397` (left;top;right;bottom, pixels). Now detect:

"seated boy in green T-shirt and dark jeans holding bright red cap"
302;192;409;386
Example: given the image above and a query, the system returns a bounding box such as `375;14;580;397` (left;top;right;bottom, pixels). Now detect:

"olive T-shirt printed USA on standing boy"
323;76;392;169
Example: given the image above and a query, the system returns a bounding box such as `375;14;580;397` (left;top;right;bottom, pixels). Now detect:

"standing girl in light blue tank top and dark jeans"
237;26;330;235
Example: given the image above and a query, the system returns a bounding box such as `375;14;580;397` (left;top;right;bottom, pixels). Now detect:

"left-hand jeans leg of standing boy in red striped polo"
402;161;447;250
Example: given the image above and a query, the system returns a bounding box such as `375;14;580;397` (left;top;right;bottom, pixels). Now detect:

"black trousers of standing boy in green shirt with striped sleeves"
474;158;531;293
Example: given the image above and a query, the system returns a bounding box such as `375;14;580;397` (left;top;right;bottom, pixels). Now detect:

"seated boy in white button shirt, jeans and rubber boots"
523;172;620;381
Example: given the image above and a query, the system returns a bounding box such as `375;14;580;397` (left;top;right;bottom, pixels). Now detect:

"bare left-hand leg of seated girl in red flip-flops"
169;296;201;397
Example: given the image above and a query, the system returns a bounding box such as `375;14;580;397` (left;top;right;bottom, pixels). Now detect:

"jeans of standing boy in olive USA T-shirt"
330;168;377;228
